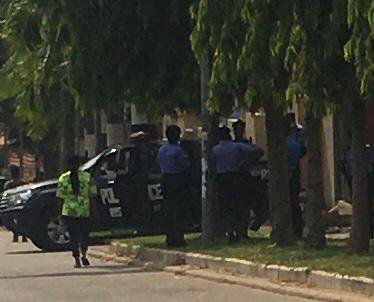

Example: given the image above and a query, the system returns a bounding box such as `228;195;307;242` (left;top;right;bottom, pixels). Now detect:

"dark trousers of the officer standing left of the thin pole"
161;174;188;246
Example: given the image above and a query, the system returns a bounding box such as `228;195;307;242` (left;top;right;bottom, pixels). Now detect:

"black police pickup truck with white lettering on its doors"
0;141;201;250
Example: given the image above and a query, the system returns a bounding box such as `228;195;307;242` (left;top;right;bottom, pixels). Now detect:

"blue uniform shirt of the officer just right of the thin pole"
213;141;256;174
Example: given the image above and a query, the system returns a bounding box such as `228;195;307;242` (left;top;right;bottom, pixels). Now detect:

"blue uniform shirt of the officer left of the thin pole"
158;143;190;174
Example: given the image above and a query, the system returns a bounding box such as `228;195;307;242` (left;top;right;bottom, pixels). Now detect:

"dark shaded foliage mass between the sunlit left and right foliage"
60;0;198;116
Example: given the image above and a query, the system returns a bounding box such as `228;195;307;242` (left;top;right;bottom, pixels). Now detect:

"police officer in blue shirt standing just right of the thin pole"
212;126;259;243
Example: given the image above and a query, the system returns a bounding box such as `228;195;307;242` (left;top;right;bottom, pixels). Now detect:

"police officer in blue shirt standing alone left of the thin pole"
158;126;190;247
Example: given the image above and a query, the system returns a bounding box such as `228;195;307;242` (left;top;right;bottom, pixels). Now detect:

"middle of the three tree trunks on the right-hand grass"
305;113;326;249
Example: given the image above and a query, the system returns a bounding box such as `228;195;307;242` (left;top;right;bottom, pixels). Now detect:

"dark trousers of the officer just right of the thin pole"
217;172;247;237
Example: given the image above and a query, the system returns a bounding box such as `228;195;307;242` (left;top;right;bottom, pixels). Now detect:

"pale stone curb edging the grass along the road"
98;242;374;302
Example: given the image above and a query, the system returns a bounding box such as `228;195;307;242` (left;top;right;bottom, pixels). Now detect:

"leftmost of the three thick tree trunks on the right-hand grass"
265;98;295;246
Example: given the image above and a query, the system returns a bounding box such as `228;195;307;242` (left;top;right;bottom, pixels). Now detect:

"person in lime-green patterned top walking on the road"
56;156;97;268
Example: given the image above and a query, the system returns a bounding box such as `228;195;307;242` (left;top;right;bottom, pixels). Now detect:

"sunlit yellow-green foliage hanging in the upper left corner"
0;0;71;137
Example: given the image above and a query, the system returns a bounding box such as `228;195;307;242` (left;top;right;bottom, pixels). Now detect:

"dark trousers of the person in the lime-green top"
63;216;91;258
